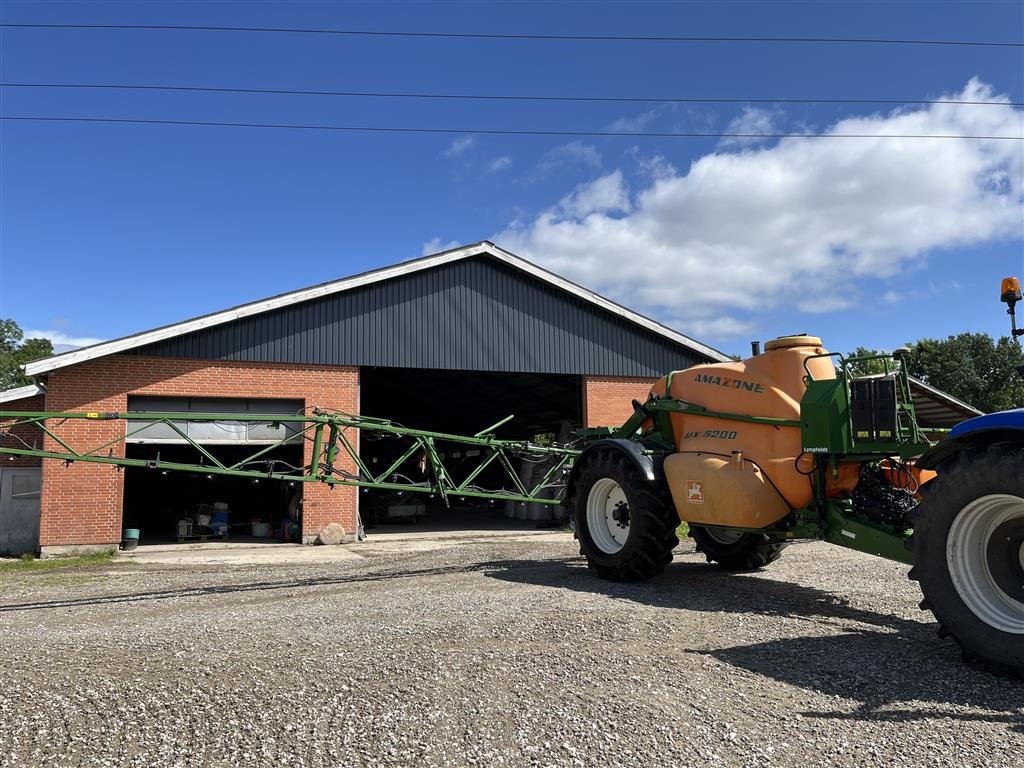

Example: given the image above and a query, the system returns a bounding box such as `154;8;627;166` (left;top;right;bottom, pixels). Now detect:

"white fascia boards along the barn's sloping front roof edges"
25;241;730;376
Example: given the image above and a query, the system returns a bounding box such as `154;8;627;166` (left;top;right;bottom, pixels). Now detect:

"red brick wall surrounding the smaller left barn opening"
39;355;358;547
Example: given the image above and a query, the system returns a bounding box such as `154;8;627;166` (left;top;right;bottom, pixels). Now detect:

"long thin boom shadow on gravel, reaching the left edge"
0;563;490;613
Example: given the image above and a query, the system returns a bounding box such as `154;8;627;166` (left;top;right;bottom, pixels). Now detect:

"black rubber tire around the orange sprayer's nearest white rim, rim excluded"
572;451;679;582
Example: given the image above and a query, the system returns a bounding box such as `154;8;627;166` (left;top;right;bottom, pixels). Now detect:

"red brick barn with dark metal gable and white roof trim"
2;242;724;554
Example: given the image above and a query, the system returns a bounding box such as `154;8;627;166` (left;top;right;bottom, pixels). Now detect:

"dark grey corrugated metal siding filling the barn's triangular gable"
129;256;707;377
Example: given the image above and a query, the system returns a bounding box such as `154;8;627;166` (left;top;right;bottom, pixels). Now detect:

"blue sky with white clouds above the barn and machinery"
0;1;1024;352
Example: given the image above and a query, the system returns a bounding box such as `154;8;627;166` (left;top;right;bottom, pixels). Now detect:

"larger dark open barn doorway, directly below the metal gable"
359;368;583;534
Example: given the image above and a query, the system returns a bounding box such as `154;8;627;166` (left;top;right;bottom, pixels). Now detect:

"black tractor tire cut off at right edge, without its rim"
907;446;1024;676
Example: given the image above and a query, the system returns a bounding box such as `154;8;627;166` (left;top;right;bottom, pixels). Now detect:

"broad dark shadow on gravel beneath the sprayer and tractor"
487;558;1024;732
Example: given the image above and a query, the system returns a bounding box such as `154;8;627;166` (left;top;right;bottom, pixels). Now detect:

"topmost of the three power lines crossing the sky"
0;24;1024;48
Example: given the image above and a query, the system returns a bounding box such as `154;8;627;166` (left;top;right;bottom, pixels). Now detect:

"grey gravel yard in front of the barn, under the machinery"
0;535;1024;768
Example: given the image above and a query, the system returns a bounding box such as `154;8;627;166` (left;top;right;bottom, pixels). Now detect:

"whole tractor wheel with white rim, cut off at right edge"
909;446;1024;674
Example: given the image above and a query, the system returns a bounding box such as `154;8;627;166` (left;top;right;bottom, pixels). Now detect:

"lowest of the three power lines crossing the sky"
0;115;1024;141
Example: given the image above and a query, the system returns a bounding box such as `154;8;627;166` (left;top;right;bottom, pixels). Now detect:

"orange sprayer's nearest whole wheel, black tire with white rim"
572;451;679;582
